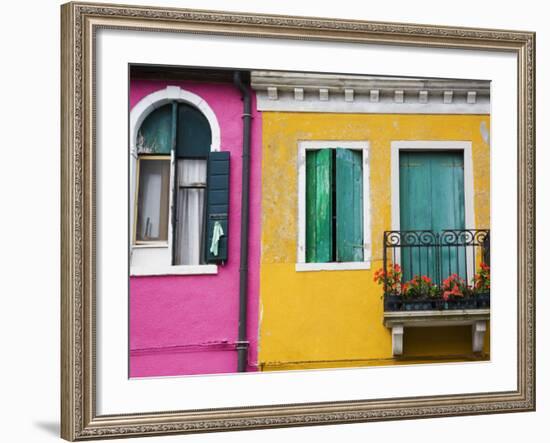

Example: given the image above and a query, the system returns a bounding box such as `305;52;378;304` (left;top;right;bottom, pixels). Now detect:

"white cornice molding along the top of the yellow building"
251;71;490;114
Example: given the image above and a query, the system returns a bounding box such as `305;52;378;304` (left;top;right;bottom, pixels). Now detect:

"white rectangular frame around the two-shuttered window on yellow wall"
296;140;372;272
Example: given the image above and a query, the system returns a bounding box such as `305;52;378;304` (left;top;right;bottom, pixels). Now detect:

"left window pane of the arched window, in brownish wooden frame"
136;159;170;241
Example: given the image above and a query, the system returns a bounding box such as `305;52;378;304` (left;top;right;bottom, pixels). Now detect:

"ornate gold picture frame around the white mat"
61;2;535;441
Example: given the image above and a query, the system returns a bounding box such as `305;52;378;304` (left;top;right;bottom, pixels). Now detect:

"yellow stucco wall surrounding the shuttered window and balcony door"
259;112;490;370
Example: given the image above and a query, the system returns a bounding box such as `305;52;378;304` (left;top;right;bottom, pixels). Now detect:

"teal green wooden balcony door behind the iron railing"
399;150;467;283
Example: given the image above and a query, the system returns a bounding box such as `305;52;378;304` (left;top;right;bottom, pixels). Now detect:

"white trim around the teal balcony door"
391;140;476;275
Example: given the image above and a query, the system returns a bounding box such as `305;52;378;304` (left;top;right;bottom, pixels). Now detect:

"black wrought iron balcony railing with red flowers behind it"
383;229;491;311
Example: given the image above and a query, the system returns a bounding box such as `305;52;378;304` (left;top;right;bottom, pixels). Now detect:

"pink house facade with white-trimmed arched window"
129;72;261;377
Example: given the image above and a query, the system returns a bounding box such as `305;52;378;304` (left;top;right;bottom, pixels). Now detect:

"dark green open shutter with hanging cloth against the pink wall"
204;151;229;263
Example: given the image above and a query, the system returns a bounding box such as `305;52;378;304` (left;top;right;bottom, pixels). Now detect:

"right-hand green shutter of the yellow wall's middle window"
336;148;363;262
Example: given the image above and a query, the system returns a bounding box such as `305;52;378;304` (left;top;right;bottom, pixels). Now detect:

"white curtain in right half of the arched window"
175;159;206;265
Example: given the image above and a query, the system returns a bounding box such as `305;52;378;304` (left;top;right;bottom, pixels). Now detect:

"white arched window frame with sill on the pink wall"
129;86;221;275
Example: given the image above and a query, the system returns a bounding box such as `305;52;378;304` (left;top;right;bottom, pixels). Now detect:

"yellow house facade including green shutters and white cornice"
252;72;490;370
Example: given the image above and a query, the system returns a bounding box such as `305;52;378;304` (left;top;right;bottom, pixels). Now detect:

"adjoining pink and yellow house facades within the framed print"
130;70;490;377
